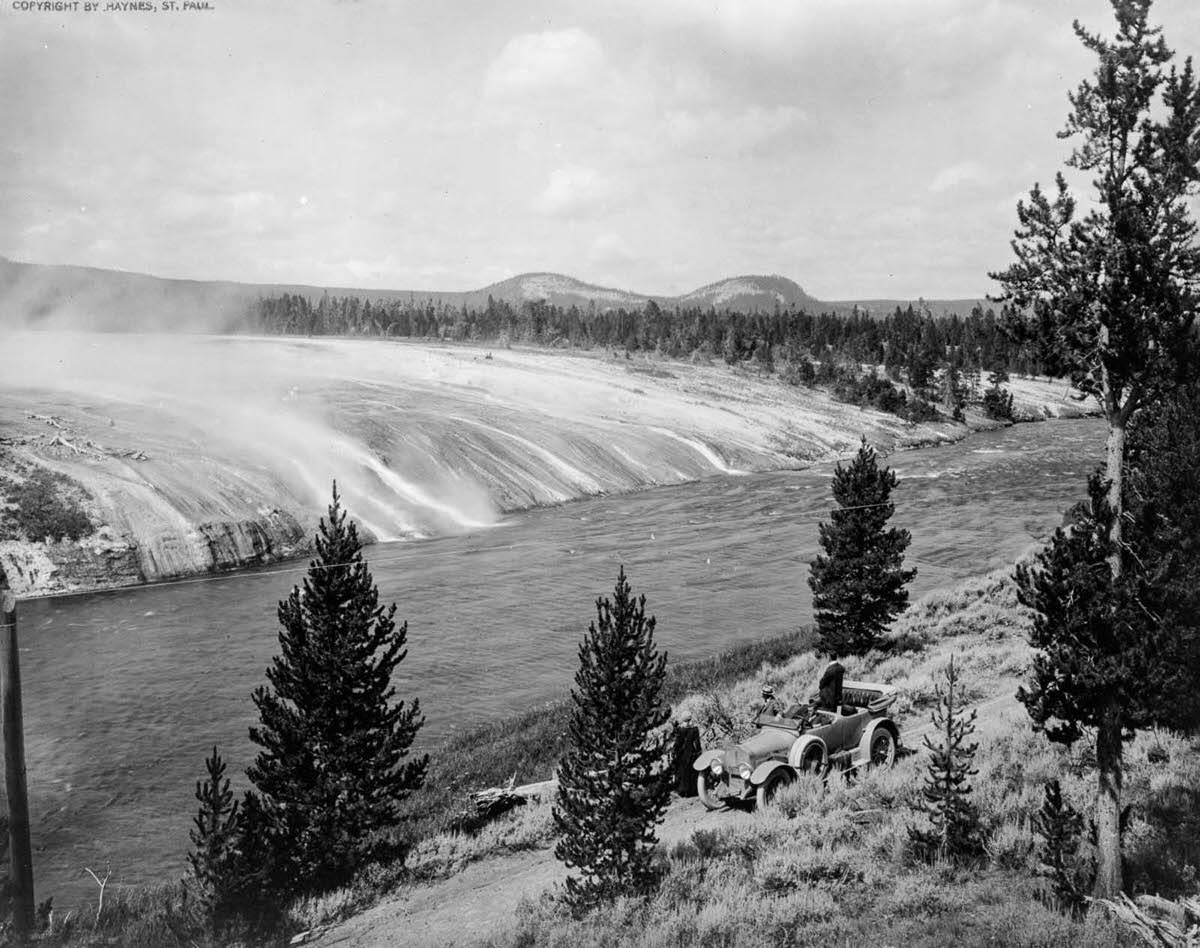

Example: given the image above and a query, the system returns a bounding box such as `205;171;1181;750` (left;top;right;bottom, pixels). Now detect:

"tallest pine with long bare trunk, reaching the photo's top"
992;0;1200;899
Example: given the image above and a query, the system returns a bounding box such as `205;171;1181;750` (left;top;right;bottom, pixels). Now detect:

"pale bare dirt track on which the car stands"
305;695;1016;948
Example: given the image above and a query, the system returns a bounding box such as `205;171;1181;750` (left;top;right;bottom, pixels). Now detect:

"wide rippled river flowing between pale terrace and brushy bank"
19;419;1104;910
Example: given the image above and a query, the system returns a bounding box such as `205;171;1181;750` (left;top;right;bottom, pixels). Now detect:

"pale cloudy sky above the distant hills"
0;0;1200;300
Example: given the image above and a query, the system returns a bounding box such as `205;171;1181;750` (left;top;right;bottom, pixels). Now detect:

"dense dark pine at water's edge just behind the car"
809;438;917;655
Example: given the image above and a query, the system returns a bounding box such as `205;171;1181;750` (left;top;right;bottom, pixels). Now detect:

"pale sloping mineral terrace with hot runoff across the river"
0;334;1090;596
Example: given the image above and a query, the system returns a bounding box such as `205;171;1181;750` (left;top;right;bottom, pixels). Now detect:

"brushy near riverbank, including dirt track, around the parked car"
46;570;1200;948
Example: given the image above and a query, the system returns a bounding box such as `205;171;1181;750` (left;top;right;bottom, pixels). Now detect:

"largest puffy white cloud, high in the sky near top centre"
484;28;605;101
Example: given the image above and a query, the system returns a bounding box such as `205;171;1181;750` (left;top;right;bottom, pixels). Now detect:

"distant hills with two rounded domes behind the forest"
0;257;988;331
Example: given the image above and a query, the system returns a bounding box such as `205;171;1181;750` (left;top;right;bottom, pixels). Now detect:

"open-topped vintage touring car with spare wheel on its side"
694;682;900;810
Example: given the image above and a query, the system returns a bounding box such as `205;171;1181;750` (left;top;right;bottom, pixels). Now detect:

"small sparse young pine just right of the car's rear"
908;658;983;862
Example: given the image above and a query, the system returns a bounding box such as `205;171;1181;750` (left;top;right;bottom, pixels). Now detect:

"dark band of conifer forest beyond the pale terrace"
246;294;1032;421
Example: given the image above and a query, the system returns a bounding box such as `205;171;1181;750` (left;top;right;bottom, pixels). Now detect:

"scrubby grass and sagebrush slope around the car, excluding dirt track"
314;574;1200;948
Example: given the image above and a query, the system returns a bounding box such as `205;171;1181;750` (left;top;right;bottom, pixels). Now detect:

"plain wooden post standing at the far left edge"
0;566;34;943
